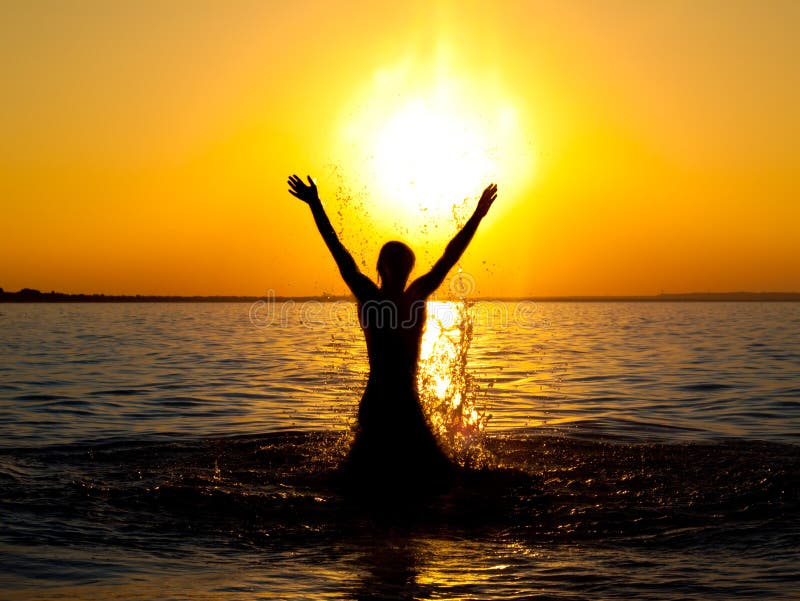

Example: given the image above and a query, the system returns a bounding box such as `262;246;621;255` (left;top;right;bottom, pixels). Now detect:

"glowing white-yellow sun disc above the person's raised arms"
337;53;534;235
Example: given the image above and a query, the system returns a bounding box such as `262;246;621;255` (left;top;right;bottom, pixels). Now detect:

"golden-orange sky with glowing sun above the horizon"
0;0;800;296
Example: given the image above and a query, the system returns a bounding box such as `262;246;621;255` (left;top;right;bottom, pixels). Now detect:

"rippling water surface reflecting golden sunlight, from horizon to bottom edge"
0;299;800;600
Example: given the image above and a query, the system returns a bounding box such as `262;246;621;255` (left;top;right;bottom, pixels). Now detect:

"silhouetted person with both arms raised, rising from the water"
288;175;497;487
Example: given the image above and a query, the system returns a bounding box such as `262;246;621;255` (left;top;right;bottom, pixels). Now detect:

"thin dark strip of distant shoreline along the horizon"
0;288;800;303
